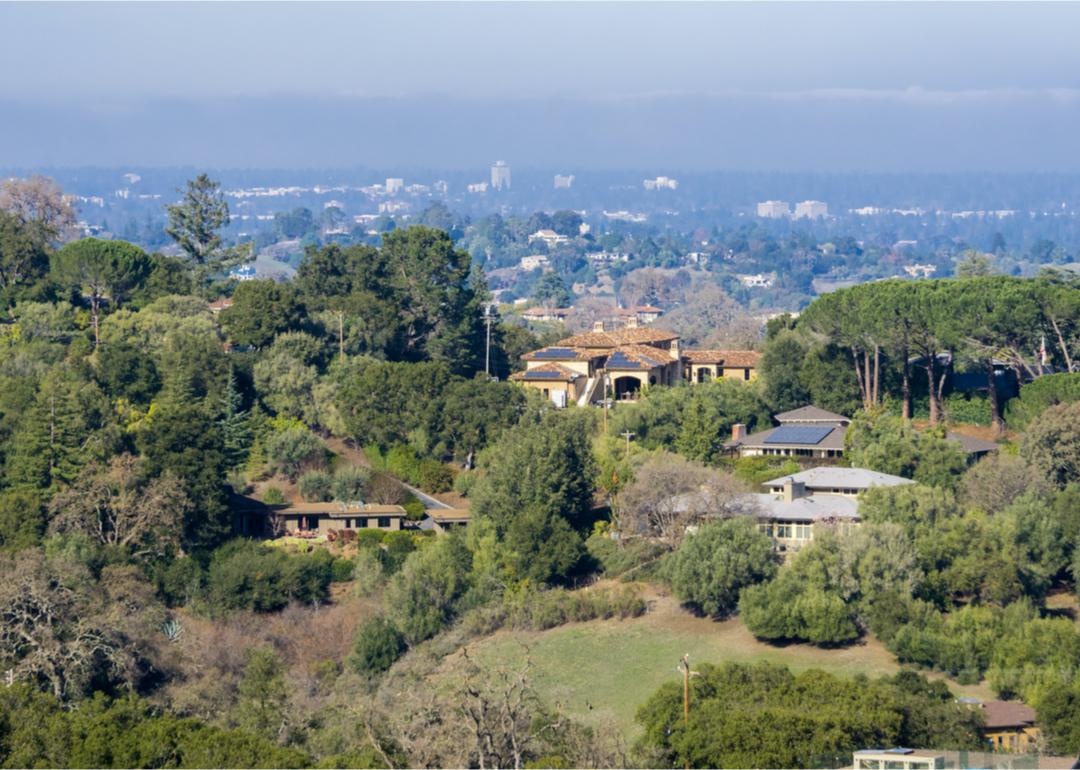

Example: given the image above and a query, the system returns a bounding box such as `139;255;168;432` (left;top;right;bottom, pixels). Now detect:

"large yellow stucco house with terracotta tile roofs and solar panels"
511;323;760;406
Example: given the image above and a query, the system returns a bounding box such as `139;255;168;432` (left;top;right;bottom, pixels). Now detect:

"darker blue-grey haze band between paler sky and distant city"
0;90;1080;172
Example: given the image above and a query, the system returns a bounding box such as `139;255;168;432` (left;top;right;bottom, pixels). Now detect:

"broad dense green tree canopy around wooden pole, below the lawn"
637;663;981;768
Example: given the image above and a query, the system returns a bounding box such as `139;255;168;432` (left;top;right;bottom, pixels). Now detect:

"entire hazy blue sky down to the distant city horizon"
0;2;1080;168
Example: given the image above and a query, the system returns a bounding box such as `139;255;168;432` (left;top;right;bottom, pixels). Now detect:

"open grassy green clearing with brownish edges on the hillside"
441;596;988;741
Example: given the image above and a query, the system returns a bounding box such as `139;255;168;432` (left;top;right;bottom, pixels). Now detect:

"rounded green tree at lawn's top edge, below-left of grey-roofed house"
664;517;777;617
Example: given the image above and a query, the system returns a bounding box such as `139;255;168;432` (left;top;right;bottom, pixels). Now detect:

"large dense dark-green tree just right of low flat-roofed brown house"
472;413;595;582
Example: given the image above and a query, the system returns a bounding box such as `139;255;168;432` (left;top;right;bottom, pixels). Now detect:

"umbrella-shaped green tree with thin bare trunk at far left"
52;238;152;348
